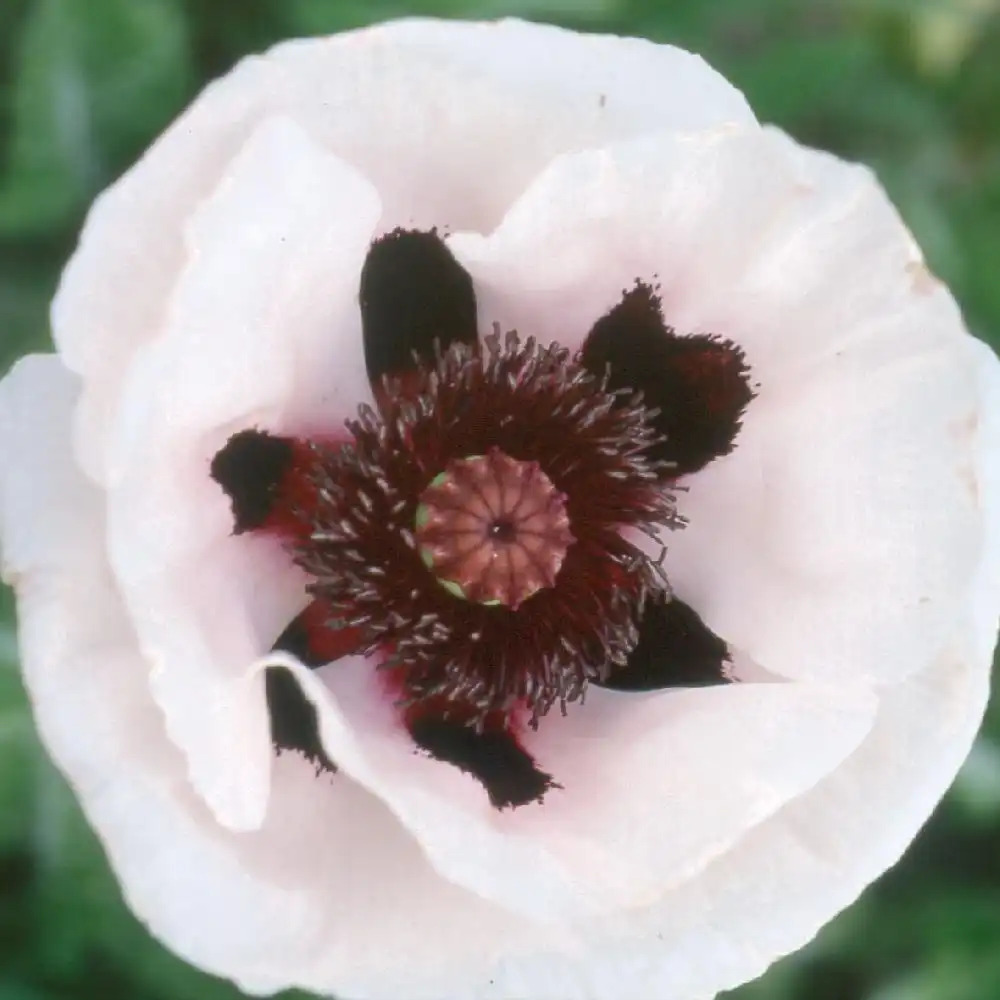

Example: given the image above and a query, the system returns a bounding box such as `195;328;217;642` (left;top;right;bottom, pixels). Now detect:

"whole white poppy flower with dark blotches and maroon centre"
0;15;1000;1000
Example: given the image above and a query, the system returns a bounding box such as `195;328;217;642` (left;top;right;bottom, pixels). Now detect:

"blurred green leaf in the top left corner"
0;0;192;235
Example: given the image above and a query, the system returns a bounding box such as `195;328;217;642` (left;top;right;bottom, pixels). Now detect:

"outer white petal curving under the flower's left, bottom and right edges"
0;260;1000;1000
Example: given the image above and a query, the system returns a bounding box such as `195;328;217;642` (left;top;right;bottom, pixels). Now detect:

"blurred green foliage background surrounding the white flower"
0;0;1000;1000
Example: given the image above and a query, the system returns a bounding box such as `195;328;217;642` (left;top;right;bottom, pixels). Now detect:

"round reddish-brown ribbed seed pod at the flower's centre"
416;448;573;608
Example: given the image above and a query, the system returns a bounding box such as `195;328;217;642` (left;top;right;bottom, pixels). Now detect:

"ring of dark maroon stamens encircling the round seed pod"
293;332;681;722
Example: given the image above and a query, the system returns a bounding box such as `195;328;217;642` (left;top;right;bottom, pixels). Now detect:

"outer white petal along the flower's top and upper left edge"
53;15;754;478
